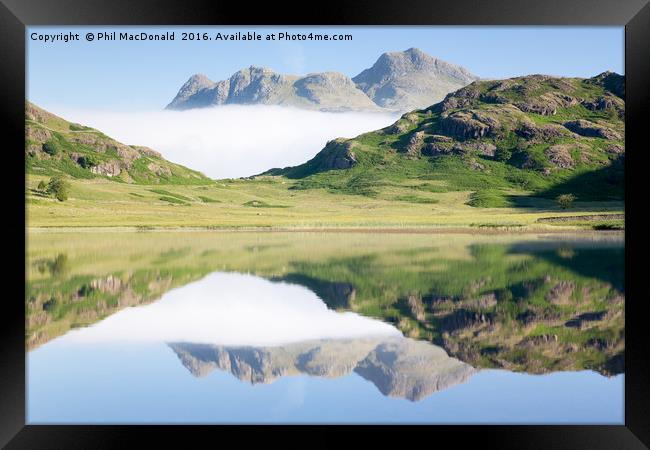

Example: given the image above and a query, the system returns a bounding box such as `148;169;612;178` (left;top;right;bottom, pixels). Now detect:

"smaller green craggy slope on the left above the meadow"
25;102;212;184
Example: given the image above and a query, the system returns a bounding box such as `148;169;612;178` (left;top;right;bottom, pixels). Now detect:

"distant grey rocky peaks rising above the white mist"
166;48;478;112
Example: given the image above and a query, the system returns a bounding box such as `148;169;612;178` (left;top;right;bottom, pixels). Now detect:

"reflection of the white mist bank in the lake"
58;272;401;346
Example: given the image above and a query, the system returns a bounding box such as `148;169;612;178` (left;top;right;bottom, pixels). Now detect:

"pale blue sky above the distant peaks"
27;26;624;111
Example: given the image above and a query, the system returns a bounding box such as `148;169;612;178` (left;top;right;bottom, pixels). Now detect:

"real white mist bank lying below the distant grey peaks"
52;105;399;178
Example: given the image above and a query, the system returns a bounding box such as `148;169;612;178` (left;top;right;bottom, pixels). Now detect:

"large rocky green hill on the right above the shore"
262;72;625;206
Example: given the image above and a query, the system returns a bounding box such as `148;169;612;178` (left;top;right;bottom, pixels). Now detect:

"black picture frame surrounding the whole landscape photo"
0;0;650;449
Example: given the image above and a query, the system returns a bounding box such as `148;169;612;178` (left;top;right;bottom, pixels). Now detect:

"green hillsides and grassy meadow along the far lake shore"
26;73;625;230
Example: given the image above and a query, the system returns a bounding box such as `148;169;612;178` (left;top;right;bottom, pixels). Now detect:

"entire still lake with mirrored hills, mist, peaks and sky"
25;231;625;424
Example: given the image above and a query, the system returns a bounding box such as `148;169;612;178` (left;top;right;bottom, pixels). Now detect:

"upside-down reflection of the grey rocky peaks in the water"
169;337;475;401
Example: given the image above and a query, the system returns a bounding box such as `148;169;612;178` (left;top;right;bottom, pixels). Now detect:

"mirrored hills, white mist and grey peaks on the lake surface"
26;233;625;422
